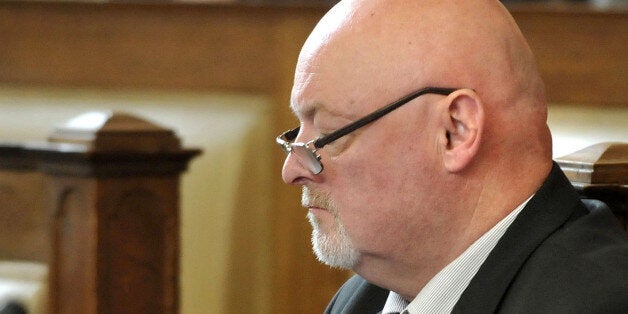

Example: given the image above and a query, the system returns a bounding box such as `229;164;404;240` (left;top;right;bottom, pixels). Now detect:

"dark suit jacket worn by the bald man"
325;165;628;314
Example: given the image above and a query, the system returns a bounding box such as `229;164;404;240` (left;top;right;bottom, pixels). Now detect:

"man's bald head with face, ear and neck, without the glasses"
282;0;551;299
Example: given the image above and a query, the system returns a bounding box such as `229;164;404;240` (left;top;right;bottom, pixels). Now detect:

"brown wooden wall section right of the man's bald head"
512;6;628;106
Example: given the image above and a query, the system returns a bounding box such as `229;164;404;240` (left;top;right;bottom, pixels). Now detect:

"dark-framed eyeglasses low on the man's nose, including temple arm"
276;87;458;174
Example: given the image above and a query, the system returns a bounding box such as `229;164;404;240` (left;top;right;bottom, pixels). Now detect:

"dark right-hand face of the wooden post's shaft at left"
98;178;178;313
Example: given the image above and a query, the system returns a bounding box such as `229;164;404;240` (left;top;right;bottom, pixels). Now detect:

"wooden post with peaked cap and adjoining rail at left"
0;112;200;313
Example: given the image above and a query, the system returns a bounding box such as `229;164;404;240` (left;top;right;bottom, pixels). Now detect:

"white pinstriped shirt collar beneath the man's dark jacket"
382;196;532;314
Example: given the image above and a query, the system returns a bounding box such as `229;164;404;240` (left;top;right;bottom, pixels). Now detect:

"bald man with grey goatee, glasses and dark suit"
277;0;628;313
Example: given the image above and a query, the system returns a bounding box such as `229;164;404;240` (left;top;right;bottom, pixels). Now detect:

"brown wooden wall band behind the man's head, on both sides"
0;1;628;105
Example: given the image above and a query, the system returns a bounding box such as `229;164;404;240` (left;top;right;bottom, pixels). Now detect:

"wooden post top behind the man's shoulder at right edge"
556;143;628;231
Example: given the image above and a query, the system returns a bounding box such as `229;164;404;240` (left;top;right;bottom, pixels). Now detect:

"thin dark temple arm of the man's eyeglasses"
312;87;457;148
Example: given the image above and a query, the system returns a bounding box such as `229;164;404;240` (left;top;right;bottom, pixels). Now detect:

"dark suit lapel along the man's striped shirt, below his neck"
452;164;579;313
